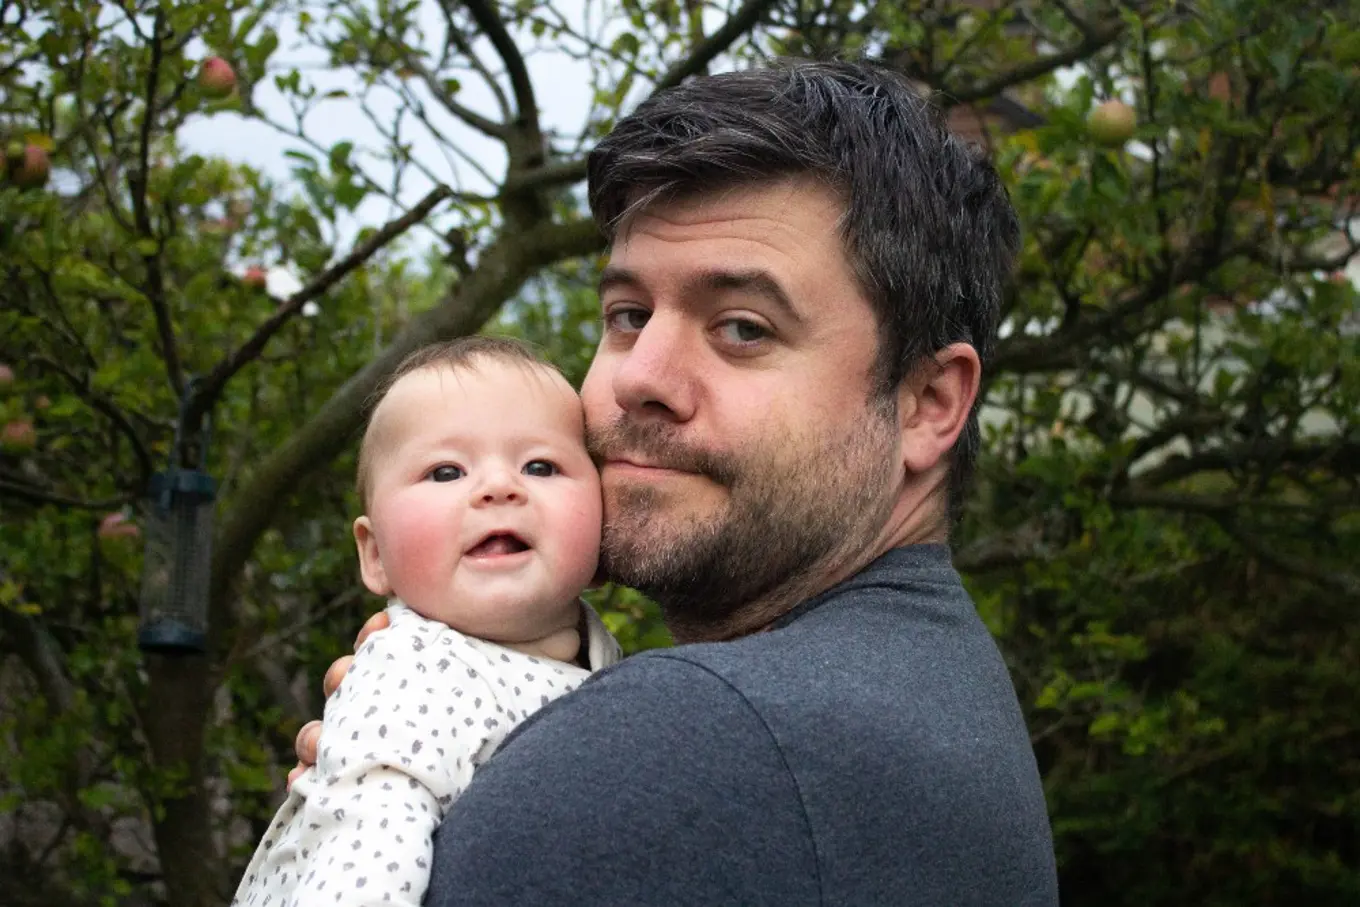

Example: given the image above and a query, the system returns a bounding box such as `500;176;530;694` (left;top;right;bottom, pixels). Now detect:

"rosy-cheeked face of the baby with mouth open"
355;359;601;643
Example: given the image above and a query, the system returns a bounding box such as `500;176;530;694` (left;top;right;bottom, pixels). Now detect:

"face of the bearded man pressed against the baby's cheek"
582;184;902;638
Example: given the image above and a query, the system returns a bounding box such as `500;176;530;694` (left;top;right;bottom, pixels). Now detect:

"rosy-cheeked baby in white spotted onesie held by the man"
233;337;620;907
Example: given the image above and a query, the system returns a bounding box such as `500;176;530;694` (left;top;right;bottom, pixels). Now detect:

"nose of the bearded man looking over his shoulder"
613;314;698;422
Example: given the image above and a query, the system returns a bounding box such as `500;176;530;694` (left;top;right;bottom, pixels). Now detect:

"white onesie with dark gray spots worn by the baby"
231;601;620;907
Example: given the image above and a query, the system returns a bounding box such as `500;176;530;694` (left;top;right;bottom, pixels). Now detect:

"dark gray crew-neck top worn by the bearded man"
426;545;1058;907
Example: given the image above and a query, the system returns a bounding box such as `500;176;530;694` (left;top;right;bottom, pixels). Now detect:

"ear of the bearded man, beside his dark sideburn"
898;343;982;475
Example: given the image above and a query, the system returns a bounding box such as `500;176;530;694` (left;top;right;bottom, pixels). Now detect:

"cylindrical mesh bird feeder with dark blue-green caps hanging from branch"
137;469;216;654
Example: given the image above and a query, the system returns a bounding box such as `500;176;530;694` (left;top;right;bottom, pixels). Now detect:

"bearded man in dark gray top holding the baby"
302;63;1057;907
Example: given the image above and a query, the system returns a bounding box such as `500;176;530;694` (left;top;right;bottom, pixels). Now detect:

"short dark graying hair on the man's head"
589;61;1020;515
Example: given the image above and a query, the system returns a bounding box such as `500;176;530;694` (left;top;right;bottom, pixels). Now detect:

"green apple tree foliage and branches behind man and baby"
0;0;1360;907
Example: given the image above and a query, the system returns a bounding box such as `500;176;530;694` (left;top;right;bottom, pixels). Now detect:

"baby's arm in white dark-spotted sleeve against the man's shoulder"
285;627;503;907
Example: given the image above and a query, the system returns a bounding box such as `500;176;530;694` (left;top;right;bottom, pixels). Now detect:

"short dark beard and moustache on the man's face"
589;404;900;638
